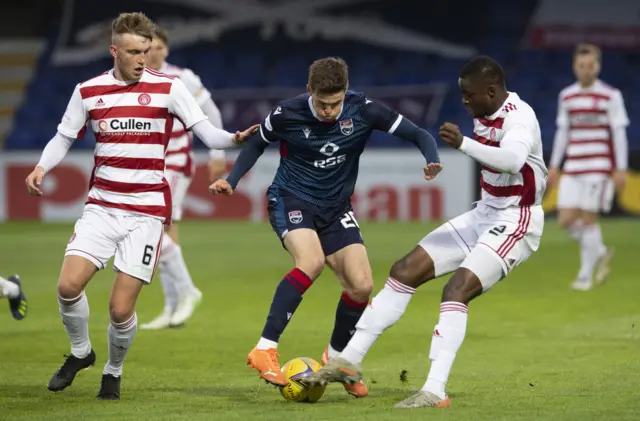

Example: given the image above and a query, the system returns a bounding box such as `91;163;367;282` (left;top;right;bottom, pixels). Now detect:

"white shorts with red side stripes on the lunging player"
419;204;544;291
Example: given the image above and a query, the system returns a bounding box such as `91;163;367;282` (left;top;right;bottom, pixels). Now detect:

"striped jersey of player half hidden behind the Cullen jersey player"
160;62;211;177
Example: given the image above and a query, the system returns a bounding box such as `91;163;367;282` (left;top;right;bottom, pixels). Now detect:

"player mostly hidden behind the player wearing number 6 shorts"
140;25;226;329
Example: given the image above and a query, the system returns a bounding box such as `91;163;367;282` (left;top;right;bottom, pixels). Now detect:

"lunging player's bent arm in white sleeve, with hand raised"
440;123;533;174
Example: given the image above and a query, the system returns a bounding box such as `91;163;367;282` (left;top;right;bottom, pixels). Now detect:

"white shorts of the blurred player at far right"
558;175;615;213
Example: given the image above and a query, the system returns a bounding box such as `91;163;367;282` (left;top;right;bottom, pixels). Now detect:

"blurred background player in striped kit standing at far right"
549;44;629;291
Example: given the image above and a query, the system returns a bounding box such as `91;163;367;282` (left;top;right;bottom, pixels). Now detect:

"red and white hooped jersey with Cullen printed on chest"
58;69;207;222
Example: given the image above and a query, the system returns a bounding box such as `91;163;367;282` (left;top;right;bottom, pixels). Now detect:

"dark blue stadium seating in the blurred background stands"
5;0;640;153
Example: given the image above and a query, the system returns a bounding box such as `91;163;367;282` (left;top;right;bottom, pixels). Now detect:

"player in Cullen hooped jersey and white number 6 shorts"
26;13;255;400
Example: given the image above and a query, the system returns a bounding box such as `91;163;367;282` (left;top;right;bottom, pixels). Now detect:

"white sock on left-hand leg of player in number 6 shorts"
58;292;91;358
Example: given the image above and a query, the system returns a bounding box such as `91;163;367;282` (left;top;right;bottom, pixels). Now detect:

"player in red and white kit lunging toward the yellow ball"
307;56;547;408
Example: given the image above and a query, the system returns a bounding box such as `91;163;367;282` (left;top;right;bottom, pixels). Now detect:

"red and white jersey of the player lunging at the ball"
473;92;547;209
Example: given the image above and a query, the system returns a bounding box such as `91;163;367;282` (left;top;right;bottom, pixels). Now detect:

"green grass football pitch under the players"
0;220;640;421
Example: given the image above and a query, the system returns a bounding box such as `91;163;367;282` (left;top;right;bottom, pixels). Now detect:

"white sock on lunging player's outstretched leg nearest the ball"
340;277;416;364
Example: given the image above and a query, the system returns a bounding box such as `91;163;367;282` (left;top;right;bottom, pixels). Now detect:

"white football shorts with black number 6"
64;205;164;283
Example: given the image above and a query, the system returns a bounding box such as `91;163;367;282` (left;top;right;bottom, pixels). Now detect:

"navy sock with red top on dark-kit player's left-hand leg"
262;268;313;342
